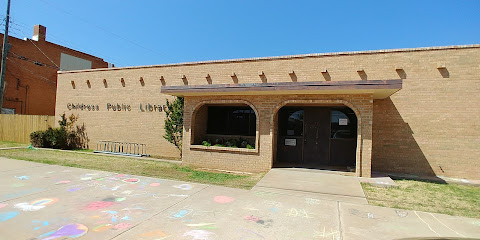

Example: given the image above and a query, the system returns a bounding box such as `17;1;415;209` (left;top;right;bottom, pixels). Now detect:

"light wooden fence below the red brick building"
0;114;55;143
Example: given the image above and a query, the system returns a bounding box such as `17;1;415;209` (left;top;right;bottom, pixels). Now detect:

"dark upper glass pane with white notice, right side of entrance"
330;108;357;138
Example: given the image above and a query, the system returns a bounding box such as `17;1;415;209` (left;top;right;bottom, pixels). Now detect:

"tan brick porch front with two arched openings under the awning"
177;94;373;176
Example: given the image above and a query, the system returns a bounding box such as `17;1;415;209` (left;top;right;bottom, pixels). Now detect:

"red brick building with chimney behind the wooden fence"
0;25;108;116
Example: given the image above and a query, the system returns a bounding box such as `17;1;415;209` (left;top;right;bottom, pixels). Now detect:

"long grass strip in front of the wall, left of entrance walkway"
0;149;264;189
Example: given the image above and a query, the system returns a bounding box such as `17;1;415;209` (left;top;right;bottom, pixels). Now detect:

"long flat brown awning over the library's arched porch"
161;79;402;99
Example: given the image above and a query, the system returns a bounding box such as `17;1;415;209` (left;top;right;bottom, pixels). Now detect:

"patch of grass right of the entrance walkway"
362;180;480;218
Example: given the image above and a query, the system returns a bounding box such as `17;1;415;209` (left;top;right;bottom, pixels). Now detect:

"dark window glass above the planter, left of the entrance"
207;106;257;136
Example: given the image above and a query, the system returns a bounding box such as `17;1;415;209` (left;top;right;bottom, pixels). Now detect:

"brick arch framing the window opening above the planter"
189;99;260;149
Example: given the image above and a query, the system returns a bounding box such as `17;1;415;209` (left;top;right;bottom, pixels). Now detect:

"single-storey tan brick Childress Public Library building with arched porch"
55;44;480;179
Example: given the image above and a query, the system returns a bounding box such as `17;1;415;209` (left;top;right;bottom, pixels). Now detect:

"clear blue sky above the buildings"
0;0;480;66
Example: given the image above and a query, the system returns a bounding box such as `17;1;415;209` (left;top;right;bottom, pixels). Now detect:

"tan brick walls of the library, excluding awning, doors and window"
57;45;480;178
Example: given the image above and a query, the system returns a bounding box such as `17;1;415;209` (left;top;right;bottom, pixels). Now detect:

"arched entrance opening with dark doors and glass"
274;105;358;172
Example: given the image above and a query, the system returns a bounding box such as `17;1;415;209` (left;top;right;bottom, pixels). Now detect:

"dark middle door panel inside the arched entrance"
303;107;330;165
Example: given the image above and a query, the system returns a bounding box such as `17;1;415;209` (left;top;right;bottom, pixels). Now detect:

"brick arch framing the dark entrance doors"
270;99;362;176
